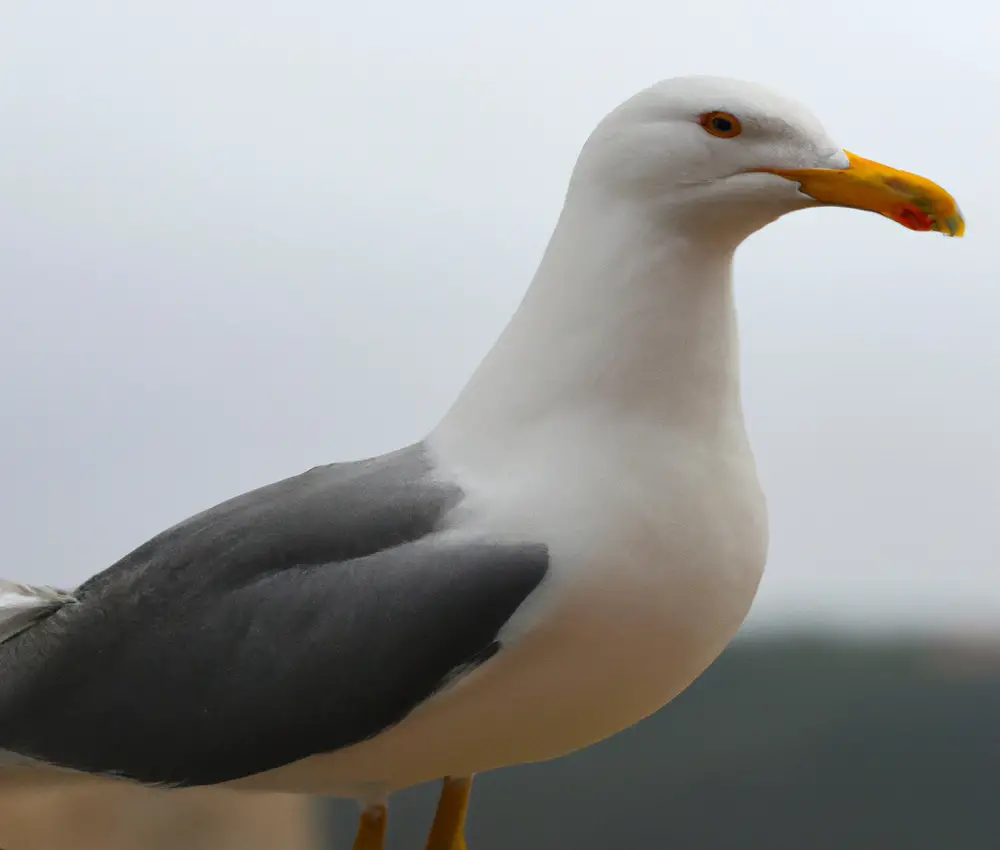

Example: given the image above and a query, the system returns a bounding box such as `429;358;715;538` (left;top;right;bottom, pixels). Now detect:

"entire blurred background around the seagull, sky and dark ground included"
0;0;1000;850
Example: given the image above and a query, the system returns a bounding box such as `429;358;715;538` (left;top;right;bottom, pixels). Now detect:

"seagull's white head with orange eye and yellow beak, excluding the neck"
570;76;964;241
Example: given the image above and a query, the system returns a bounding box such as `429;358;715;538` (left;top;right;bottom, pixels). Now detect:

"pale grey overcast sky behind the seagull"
0;0;1000;628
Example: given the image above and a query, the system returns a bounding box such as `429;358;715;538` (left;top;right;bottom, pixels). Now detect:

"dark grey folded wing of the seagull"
0;445;548;785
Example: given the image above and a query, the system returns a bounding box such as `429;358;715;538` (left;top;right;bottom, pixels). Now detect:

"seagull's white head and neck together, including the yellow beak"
432;77;964;454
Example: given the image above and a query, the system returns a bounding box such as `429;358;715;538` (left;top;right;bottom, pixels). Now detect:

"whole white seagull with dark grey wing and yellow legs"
0;76;965;850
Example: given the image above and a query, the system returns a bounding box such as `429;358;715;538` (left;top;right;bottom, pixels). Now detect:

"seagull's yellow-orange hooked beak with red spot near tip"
754;151;965;236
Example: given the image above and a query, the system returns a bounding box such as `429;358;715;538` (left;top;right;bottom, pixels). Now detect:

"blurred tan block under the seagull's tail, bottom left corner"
0;784;319;850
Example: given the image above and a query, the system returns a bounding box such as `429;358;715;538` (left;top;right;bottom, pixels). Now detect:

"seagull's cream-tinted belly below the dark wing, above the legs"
233;490;763;797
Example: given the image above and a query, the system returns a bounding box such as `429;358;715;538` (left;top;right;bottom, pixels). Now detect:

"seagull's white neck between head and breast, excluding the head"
438;189;742;446
